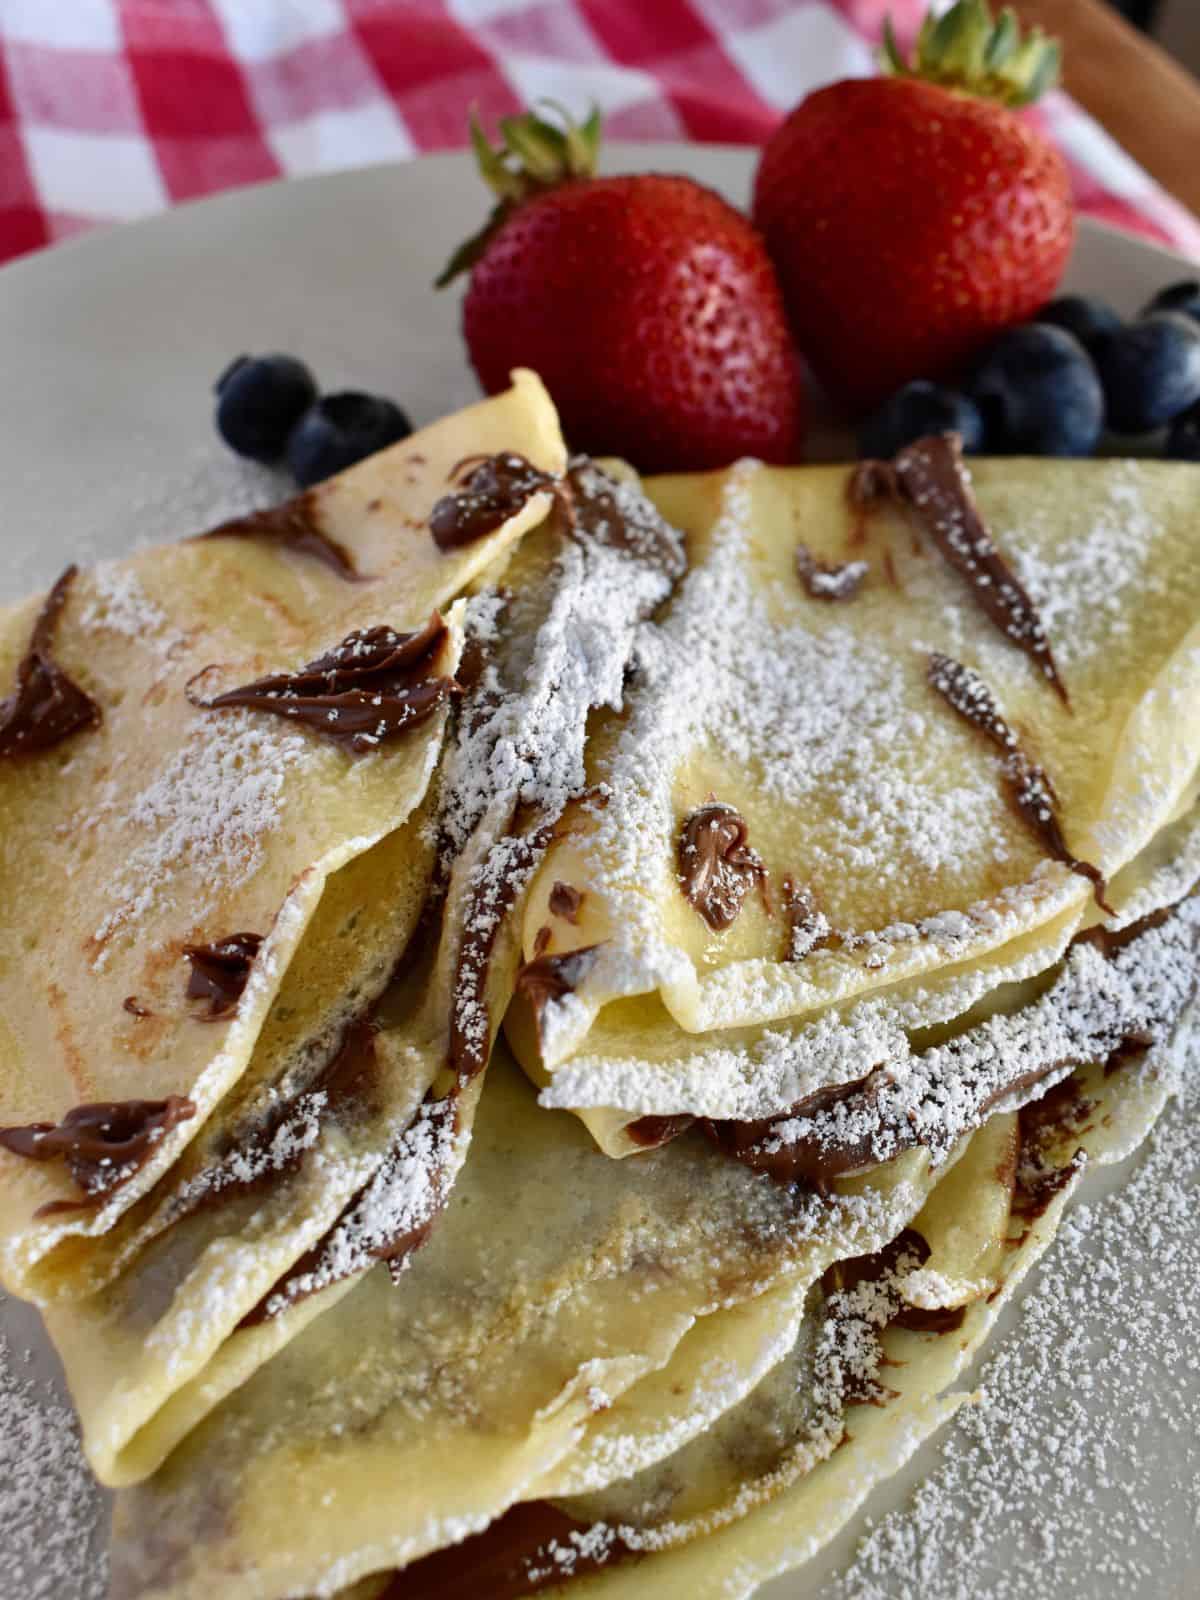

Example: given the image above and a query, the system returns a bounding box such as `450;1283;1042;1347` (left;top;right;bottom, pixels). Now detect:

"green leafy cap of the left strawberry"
434;99;600;290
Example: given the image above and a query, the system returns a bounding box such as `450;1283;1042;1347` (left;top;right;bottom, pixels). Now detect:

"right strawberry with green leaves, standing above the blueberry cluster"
754;0;1074;411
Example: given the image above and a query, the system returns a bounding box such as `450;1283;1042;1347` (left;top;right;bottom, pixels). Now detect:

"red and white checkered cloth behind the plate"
0;0;1200;261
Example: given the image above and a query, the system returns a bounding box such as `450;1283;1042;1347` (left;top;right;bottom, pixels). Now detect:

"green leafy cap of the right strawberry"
880;0;1062;106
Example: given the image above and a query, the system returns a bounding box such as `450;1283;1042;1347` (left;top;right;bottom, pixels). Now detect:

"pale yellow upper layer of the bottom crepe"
103;1061;947;1600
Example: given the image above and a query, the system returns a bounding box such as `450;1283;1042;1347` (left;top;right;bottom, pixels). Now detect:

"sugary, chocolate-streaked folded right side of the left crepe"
28;464;682;1483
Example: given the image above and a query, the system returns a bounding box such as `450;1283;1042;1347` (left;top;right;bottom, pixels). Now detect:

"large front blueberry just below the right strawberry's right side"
968;322;1104;456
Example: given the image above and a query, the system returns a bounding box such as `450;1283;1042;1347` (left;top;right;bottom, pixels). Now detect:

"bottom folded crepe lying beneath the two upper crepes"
114;864;1200;1600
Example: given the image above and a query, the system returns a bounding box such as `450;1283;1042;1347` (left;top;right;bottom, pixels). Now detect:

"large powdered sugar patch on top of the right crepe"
553;462;1036;1026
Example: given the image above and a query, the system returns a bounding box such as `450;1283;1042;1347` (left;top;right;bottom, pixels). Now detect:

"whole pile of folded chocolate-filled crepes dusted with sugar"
0;373;1200;1600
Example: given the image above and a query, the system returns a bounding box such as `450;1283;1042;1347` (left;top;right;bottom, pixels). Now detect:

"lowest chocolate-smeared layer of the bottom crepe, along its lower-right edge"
483;1016;1197;1600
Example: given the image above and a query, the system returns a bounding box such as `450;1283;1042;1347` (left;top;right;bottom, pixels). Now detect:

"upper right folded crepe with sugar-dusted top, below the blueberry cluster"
510;440;1200;1155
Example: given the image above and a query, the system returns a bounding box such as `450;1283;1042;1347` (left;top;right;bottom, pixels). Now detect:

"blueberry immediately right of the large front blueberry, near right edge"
1096;310;1200;434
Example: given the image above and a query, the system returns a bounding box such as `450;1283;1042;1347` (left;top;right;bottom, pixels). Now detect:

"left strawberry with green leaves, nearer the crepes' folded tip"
438;103;803;472
